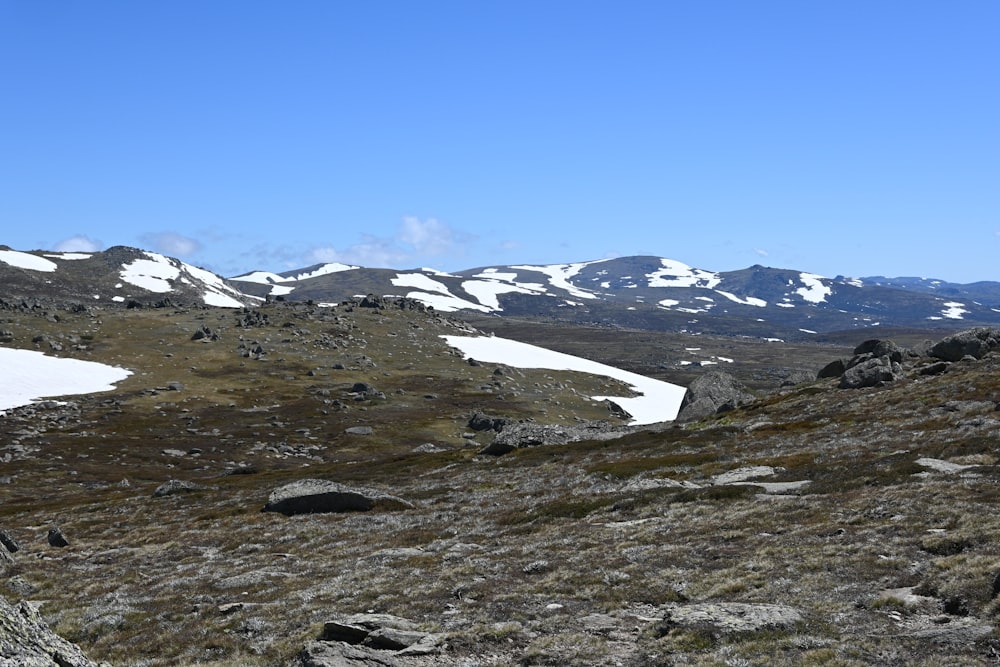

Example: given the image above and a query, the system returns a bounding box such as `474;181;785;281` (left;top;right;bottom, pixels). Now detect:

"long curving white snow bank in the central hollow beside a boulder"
442;336;687;425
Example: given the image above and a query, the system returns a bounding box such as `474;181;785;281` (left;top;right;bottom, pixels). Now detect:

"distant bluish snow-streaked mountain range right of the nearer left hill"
232;256;1000;336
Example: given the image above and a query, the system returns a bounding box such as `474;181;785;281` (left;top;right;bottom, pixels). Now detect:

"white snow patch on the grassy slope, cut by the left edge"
0;347;132;412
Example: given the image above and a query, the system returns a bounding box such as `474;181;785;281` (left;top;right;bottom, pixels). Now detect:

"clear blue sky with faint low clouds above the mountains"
0;0;1000;282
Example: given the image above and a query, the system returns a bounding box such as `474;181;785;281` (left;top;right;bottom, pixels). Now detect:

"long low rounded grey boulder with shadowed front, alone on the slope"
263;479;413;516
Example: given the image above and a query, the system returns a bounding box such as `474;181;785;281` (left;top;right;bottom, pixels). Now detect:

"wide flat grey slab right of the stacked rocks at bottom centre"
662;602;804;635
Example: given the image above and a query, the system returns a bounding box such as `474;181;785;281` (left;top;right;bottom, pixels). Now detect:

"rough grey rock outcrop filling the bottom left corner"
0;598;98;667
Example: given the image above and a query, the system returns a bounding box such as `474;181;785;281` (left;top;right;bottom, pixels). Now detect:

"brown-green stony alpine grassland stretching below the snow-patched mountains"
0;299;1000;667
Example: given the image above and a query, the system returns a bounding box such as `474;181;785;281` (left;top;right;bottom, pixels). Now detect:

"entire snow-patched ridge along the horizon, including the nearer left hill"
0;246;1000;339
